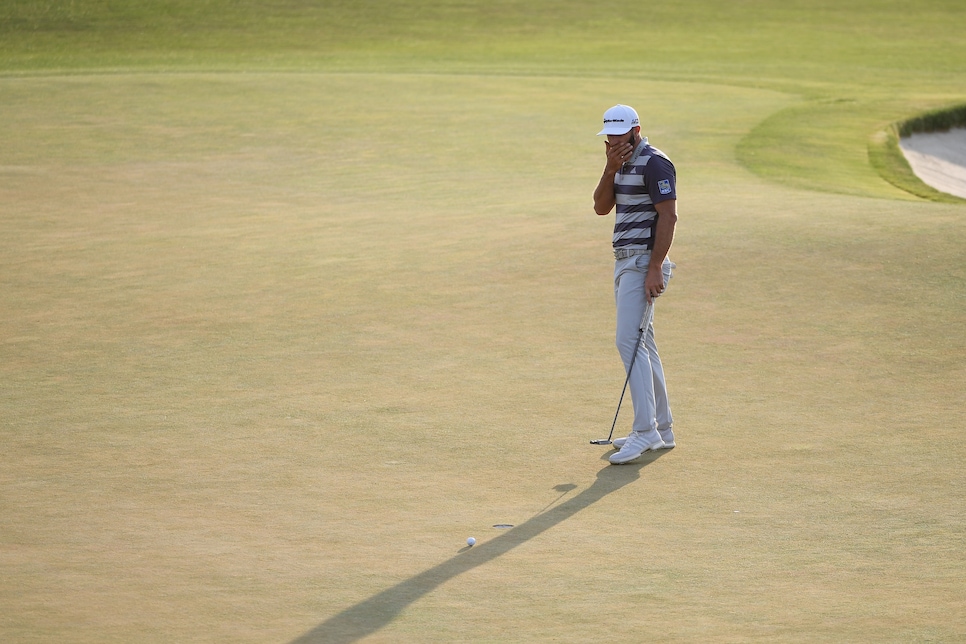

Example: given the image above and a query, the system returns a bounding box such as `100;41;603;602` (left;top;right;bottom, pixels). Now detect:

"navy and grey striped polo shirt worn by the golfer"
614;137;677;250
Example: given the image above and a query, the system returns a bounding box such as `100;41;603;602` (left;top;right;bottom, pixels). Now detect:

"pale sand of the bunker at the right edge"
899;128;966;199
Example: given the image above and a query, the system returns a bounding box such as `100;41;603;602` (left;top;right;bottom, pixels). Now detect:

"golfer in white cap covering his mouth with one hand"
594;105;678;465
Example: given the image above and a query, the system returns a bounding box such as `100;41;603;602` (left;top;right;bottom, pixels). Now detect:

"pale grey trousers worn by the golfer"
614;255;674;432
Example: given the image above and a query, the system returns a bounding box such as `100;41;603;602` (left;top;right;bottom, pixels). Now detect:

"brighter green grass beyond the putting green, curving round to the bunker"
0;0;966;196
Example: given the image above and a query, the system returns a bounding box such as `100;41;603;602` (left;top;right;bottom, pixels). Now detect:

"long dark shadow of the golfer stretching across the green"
292;452;664;644
